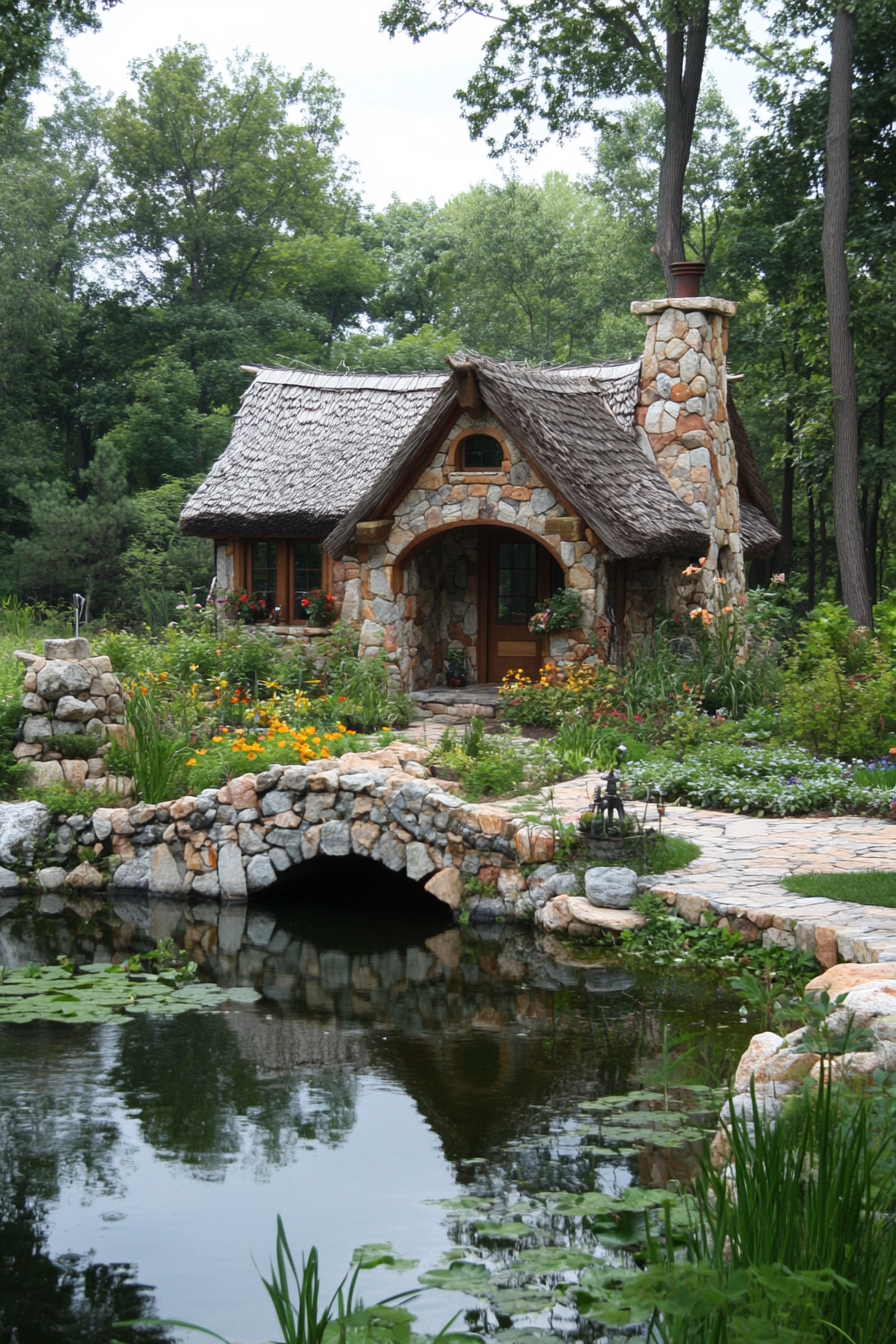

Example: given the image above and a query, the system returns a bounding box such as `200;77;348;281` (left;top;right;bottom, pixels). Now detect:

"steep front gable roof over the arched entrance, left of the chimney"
325;356;708;558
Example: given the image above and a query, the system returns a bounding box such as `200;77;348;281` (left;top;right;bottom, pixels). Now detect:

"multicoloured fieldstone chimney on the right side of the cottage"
631;298;747;610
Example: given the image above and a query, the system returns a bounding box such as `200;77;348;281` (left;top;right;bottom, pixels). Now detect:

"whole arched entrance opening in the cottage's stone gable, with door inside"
396;523;564;688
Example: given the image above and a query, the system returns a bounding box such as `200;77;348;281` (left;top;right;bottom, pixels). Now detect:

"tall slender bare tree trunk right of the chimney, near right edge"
821;9;872;625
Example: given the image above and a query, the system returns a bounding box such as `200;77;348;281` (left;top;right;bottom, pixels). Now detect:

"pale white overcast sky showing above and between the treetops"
52;0;752;208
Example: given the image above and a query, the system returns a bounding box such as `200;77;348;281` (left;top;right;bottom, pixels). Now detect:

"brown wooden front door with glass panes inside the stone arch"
480;527;563;681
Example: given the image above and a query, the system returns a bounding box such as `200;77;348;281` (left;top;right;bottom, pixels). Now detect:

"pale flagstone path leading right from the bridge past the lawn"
545;774;896;965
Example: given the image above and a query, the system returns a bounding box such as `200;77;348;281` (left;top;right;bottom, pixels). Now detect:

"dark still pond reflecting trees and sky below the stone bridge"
0;860;751;1344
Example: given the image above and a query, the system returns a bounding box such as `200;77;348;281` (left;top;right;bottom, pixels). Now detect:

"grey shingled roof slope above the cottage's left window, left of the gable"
180;368;446;538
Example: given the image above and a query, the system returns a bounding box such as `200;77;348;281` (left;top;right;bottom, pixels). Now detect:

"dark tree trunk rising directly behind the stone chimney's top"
654;3;709;294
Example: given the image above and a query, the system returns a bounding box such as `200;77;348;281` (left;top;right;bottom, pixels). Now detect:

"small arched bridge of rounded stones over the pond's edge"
105;743;553;919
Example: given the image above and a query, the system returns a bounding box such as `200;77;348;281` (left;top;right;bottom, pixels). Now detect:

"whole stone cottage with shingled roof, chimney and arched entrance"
180;288;779;691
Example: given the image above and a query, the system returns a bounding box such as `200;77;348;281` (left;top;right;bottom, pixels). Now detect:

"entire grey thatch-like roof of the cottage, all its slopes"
180;355;778;558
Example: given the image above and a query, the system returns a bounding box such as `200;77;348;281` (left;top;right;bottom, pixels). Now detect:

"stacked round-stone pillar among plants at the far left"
13;638;132;794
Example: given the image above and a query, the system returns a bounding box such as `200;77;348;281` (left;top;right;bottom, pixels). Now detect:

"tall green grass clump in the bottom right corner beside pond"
627;1078;896;1344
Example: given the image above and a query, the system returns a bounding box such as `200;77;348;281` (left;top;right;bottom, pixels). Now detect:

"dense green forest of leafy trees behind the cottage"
0;0;896;625
